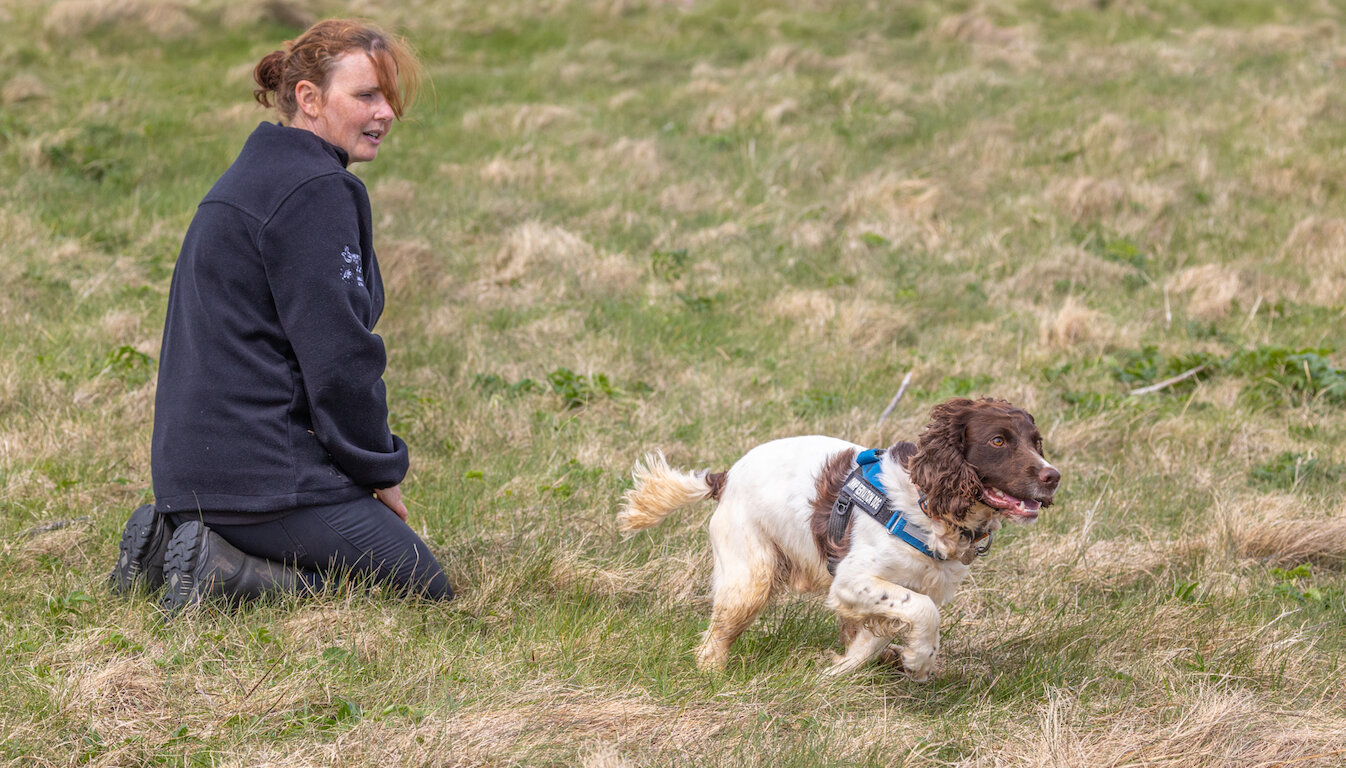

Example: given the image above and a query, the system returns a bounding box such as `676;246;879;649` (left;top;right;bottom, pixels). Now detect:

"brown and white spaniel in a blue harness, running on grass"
618;398;1061;682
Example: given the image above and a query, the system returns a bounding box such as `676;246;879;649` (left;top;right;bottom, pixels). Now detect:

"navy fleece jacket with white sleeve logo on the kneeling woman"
151;122;408;514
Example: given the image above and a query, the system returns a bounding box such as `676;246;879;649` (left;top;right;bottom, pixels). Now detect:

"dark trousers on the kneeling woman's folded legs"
171;496;454;600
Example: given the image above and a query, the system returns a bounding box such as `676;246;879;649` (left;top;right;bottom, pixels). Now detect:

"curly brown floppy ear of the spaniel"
907;398;981;522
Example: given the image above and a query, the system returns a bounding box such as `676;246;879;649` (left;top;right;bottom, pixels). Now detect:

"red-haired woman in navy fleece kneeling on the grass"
113;19;454;609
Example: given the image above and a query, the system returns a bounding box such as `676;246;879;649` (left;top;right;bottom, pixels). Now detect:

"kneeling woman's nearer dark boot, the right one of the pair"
160;521;306;612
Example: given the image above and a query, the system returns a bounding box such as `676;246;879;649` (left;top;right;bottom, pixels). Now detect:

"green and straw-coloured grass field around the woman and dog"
0;0;1346;768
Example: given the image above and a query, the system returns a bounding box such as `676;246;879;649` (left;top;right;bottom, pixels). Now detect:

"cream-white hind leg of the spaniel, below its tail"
696;508;775;670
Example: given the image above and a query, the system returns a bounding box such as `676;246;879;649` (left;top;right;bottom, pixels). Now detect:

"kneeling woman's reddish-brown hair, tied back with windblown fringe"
253;19;421;121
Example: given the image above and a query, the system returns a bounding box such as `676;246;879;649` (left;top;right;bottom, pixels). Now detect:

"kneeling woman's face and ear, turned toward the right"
295;50;393;163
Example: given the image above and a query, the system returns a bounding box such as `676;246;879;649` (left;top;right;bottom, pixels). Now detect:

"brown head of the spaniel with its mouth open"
907;398;1061;525
